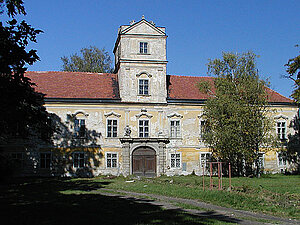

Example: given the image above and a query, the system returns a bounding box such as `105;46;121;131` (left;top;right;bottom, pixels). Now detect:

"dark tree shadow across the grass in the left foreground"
0;178;239;225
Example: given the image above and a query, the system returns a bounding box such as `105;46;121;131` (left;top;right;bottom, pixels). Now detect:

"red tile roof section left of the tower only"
26;71;119;99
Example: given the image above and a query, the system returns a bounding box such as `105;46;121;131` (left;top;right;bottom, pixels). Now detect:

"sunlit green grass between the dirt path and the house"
85;175;300;219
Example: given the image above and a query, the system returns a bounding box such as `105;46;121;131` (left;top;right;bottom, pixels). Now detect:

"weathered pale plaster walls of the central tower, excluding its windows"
115;21;167;103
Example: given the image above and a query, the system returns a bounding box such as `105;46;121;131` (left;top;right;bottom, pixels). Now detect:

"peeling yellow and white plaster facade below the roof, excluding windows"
39;103;297;175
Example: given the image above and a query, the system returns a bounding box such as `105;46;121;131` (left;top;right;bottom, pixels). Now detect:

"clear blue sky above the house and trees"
3;0;300;97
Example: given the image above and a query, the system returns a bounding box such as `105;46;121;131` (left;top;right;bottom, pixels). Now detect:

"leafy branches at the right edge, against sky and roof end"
285;45;300;103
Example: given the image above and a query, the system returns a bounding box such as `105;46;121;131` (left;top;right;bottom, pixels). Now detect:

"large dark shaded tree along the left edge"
0;0;54;144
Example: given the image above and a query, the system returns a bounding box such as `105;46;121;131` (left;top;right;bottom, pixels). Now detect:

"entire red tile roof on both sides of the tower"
26;71;292;103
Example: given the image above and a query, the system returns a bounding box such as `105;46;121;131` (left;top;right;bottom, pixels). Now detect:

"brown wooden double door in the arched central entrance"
132;147;156;177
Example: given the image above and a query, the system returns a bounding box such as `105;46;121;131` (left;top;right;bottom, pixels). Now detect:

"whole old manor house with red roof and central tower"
12;18;298;176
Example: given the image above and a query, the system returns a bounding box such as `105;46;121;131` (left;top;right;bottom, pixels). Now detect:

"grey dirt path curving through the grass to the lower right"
93;189;300;224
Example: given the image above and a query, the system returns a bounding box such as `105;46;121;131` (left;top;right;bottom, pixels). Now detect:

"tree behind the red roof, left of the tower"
61;46;113;73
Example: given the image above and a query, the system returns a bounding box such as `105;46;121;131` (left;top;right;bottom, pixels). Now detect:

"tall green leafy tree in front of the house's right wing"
199;52;275;175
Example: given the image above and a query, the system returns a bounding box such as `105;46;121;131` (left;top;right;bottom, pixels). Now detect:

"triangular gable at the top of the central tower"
121;19;166;35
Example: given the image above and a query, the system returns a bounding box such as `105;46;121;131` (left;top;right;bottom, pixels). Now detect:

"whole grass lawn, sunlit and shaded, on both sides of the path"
0;175;300;225
